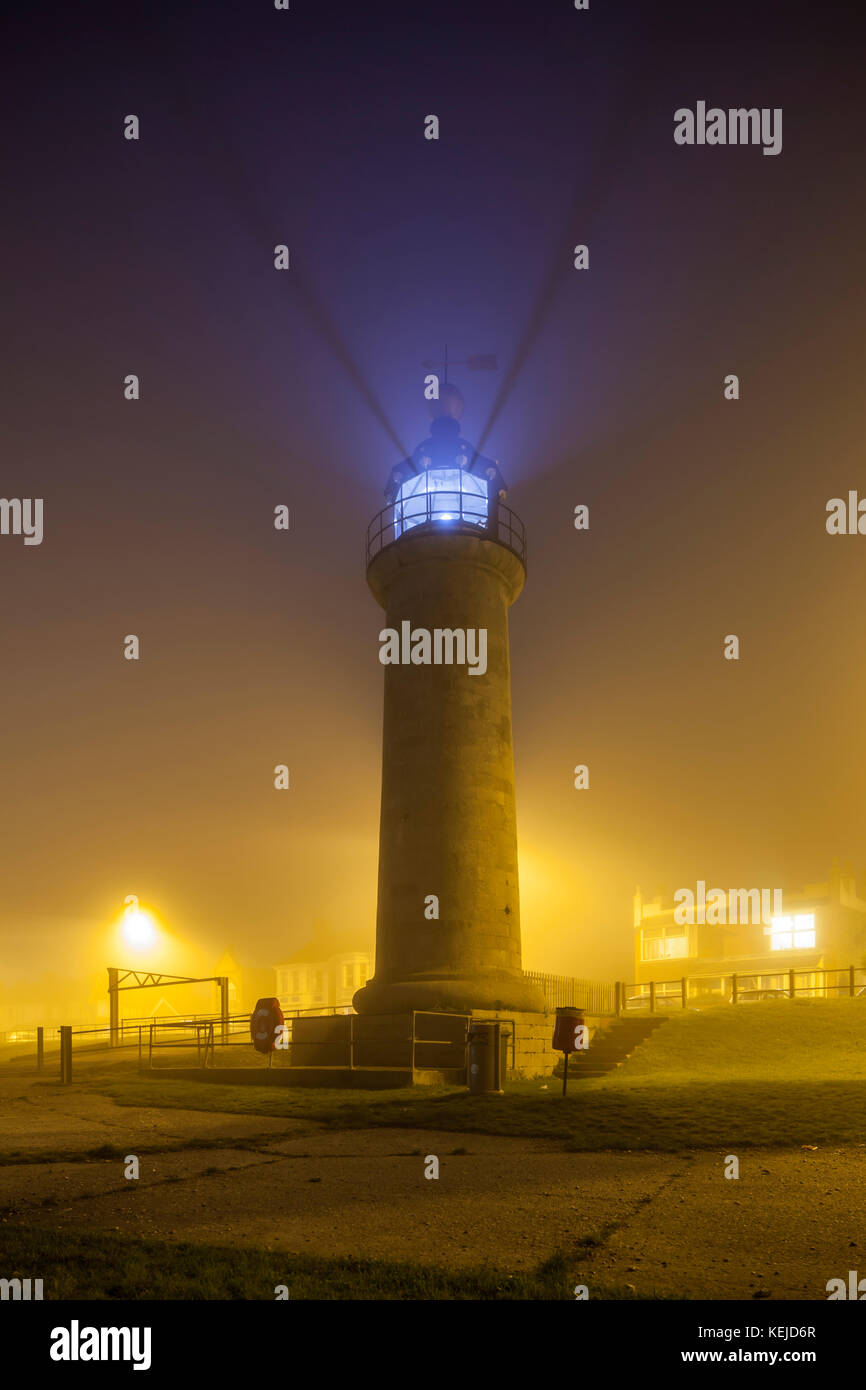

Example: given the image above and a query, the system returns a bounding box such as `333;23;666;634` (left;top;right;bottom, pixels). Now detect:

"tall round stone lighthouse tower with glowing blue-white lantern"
354;384;545;1013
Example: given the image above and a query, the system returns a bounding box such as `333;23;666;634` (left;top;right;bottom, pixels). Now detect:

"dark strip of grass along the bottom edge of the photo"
3;1223;667;1301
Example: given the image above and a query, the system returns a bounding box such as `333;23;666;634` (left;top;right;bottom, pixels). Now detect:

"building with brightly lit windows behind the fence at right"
632;862;866;1004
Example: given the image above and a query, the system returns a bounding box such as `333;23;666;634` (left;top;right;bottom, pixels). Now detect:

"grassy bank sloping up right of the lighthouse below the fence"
59;999;866;1152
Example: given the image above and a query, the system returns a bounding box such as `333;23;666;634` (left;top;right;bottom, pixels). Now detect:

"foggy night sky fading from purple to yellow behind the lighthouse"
0;0;866;1000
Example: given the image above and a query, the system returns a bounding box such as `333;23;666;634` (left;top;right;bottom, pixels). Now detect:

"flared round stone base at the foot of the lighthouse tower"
352;970;546;1013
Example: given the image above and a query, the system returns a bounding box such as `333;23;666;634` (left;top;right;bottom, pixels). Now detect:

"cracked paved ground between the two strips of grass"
0;1087;866;1300
